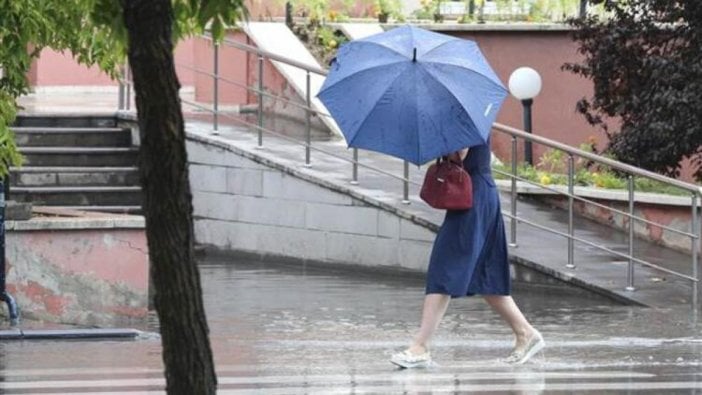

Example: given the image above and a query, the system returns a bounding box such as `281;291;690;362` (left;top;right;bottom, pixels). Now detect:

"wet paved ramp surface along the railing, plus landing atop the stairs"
16;94;692;307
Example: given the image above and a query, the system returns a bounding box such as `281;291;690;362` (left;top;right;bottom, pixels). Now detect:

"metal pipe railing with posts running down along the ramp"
119;31;702;312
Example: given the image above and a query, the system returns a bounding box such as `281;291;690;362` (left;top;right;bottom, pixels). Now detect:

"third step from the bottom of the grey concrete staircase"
19;147;139;166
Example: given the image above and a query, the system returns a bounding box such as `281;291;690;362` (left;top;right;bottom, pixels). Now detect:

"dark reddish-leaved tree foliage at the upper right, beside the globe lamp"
564;0;702;180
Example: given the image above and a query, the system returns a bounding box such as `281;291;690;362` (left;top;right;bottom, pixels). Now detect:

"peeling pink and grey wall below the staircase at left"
7;227;149;325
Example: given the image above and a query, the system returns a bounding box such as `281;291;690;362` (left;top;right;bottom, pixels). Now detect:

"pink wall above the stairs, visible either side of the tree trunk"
27;39;195;87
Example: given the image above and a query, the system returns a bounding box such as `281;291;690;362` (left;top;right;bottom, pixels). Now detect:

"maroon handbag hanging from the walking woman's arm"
419;157;473;210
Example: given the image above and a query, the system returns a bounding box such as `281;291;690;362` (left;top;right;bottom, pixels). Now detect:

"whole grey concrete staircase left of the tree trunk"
10;115;141;213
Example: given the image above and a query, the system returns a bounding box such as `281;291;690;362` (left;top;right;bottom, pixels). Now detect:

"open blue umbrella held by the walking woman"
318;26;507;165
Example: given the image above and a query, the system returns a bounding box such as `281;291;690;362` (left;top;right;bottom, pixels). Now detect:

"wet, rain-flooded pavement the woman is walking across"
0;257;702;394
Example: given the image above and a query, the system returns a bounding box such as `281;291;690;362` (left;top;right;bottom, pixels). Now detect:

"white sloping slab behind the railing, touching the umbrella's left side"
242;22;341;136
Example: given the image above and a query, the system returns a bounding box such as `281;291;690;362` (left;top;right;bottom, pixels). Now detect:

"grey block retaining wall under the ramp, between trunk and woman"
188;140;434;271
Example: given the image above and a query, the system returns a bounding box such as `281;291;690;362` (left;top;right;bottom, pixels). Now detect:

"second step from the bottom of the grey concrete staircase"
10;166;139;188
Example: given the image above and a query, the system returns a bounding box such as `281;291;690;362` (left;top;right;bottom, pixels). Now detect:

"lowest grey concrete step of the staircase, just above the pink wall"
10;186;141;206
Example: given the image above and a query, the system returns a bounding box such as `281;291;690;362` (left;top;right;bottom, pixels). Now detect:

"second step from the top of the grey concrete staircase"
12;126;132;147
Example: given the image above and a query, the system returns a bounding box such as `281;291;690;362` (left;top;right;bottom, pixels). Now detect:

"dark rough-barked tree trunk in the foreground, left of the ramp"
121;0;217;395
